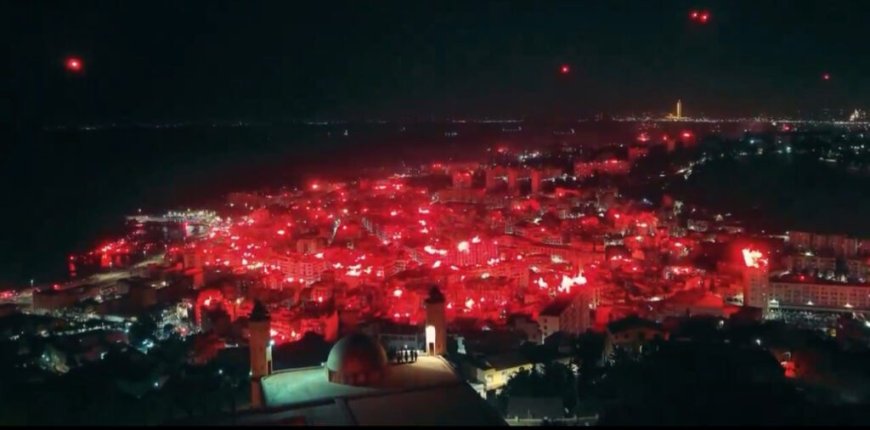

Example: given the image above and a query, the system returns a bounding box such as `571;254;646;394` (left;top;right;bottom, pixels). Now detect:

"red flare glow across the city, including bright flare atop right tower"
55;146;860;412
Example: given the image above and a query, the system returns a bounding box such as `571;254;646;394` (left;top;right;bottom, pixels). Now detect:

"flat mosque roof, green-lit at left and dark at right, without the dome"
245;356;505;426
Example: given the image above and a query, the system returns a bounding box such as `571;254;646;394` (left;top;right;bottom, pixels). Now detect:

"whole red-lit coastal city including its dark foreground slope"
2;109;870;425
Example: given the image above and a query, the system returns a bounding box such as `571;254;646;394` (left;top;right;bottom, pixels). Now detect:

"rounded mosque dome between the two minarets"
326;333;387;385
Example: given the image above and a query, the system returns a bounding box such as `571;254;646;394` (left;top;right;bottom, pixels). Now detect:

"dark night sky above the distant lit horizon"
10;0;870;124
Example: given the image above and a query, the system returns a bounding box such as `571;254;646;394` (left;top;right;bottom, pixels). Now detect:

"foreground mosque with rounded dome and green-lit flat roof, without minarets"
226;334;506;426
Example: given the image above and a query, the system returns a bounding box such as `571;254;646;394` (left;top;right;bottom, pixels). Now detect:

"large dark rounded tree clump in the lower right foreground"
595;343;802;425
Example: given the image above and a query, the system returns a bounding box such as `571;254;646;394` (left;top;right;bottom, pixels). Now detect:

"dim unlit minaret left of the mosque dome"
248;300;272;409
